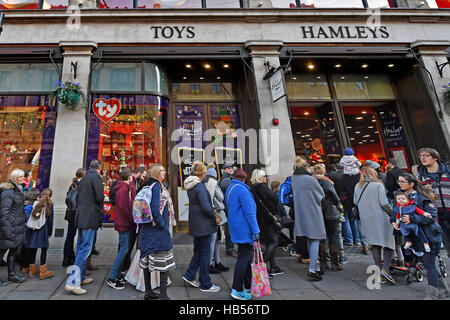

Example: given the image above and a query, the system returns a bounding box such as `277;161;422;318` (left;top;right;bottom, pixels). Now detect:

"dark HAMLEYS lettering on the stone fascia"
300;26;390;39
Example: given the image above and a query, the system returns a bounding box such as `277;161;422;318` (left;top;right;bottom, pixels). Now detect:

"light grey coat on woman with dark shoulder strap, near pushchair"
353;178;395;250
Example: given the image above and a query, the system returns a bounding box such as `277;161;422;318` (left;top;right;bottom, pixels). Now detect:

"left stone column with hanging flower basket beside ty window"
50;41;97;248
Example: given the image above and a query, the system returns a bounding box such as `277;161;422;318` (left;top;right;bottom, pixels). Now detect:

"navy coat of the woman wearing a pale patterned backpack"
138;178;173;258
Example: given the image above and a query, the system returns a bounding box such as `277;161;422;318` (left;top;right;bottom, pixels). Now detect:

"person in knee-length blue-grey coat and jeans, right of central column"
291;157;327;281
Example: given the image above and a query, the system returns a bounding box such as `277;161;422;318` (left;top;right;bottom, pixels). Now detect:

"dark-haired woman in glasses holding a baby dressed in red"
394;172;445;300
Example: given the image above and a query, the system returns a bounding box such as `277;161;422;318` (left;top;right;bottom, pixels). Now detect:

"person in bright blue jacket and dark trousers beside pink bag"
225;169;260;300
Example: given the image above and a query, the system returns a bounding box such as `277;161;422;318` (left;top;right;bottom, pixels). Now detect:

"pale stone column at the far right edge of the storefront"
411;41;450;152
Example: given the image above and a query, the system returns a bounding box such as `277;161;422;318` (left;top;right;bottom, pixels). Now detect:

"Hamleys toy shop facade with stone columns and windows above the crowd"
0;3;450;247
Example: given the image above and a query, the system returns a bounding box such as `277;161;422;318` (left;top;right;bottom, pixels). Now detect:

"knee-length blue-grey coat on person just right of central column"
291;169;326;240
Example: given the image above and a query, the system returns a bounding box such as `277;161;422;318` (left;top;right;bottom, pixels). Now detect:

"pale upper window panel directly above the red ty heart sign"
92;63;142;91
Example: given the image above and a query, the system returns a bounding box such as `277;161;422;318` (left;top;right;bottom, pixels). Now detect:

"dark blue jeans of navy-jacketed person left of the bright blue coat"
184;235;213;289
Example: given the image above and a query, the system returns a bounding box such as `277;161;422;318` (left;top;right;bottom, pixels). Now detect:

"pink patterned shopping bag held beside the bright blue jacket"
251;241;272;298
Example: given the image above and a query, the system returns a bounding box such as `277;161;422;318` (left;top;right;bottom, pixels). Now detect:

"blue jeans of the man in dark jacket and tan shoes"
66;229;97;286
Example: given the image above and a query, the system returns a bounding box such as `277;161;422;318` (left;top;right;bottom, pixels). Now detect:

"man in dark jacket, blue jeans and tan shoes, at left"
65;160;104;295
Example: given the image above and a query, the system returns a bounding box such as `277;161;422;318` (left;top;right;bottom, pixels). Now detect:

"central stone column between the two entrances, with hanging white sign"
245;40;295;182
